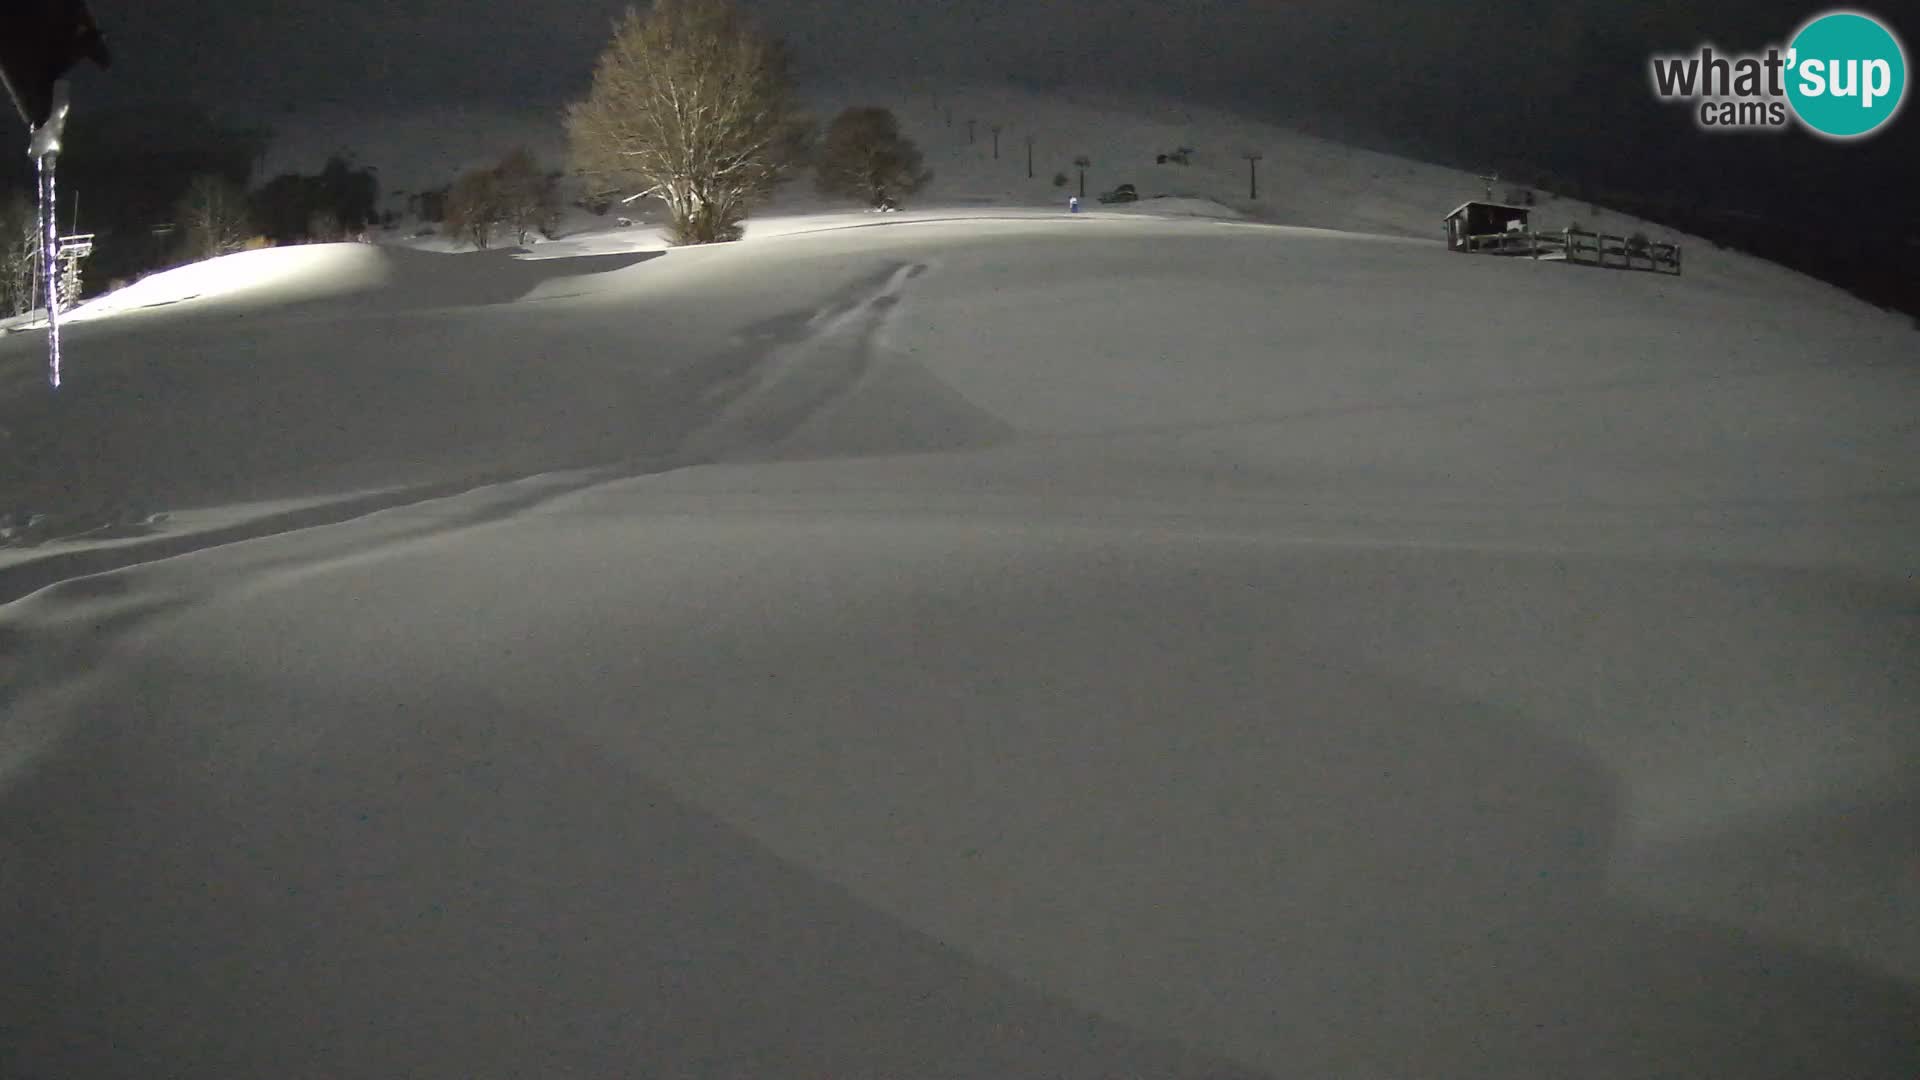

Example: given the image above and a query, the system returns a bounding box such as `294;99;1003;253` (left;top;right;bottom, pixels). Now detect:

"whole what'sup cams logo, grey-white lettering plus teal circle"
1649;12;1907;138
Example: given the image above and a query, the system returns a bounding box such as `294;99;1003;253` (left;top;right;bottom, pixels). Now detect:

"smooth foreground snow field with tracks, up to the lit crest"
0;193;1920;1080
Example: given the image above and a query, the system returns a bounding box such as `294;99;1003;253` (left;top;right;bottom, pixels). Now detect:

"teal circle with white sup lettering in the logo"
1788;12;1907;138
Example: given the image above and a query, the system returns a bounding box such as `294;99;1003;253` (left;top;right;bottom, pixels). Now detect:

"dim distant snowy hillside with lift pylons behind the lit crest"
311;85;1853;309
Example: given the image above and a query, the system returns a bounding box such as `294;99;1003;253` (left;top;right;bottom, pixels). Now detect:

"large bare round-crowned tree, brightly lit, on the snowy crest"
566;0;808;244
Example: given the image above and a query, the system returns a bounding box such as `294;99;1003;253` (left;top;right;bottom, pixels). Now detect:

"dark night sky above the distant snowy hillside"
37;0;1920;294
